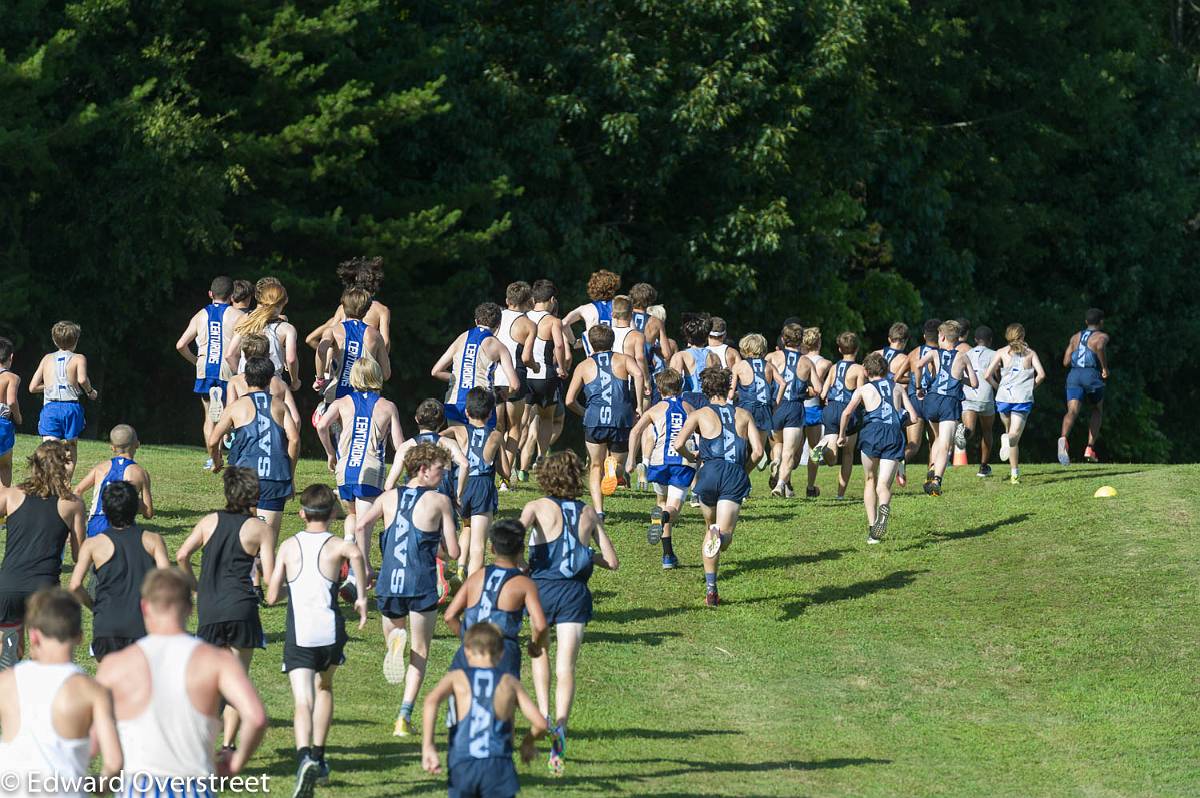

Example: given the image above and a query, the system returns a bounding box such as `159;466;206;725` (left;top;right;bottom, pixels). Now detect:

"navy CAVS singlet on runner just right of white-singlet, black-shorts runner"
376;487;442;598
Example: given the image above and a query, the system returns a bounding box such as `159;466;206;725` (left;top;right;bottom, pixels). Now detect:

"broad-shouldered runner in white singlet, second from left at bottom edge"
96;568;266;798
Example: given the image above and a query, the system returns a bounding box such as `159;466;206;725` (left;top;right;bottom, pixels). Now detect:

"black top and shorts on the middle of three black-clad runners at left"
91;526;155;661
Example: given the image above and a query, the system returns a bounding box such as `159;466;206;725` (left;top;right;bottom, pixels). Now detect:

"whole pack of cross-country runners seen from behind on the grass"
0;258;1108;796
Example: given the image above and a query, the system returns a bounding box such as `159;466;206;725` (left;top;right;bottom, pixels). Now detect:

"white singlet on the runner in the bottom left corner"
0;660;91;798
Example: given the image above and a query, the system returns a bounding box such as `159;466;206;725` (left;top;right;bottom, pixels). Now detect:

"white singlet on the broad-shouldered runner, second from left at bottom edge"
116;634;221;778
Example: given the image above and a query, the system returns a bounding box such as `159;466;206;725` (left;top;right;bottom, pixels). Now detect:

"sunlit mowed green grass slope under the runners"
4;437;1200;797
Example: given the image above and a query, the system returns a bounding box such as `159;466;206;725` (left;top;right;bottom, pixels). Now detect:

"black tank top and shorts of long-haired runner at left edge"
0;496;71;625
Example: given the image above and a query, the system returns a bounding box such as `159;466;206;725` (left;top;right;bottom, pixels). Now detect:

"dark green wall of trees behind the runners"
0;0;1200;460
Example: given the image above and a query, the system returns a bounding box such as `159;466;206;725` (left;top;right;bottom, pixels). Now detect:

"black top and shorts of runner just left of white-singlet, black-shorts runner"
196;510;266;648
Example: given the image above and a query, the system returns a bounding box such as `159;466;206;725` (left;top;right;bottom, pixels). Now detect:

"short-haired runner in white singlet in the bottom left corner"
0;587;121;797
